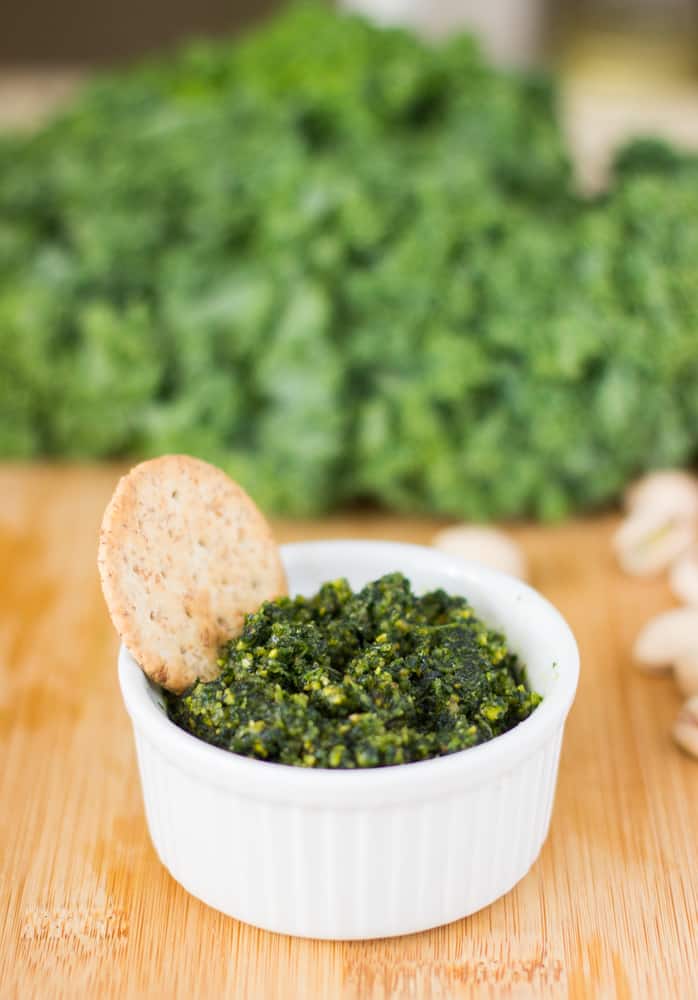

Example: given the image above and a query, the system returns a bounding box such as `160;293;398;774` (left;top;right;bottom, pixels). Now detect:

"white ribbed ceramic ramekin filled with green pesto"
119;541;579;939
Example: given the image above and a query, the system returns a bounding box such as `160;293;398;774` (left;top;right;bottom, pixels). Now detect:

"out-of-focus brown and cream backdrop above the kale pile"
5;0;698;189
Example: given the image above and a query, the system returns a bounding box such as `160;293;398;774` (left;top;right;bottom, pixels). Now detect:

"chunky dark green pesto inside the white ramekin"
166;573;541;768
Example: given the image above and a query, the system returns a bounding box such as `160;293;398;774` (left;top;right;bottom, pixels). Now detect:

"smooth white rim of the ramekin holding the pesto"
119;539;579;807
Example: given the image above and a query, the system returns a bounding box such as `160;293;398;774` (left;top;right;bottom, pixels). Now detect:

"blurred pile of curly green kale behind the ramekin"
0;6;698;518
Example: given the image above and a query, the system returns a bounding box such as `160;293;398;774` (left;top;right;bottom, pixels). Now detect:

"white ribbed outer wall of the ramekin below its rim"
136;727;562;939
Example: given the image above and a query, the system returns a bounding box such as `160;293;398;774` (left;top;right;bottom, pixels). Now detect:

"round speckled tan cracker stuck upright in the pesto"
98;455;286;692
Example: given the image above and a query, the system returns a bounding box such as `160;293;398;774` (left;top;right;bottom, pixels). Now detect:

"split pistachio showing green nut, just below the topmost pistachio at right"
613;508;696;576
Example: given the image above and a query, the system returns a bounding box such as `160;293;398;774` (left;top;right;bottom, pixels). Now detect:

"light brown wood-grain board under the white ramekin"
0;466;698;1000
